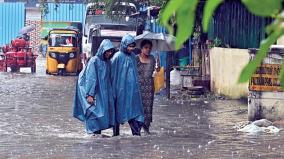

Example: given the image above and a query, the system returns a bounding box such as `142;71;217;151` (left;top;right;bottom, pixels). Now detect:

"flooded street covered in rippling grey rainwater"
0;58;284;159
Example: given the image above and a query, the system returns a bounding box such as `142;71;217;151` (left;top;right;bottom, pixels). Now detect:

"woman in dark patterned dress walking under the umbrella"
136;40;159;134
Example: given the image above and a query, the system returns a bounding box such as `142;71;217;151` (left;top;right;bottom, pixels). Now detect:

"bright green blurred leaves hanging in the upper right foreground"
160;0;284;86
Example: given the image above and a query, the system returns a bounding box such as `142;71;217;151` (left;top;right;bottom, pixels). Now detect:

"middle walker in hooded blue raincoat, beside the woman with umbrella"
111;34;144;136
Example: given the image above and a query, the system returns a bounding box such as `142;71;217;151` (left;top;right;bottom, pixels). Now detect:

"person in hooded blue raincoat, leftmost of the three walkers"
73;39;115;134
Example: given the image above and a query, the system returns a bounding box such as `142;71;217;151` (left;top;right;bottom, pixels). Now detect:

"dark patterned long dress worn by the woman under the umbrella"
136;55;156;131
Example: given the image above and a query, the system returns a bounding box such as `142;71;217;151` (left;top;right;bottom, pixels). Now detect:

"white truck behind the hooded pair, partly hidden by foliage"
82;2;137;58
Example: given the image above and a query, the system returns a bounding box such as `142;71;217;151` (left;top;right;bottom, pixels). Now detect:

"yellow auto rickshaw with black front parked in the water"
46;29;83;75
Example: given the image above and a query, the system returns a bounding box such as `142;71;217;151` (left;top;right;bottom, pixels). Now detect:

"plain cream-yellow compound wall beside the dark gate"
210;48;249;99
